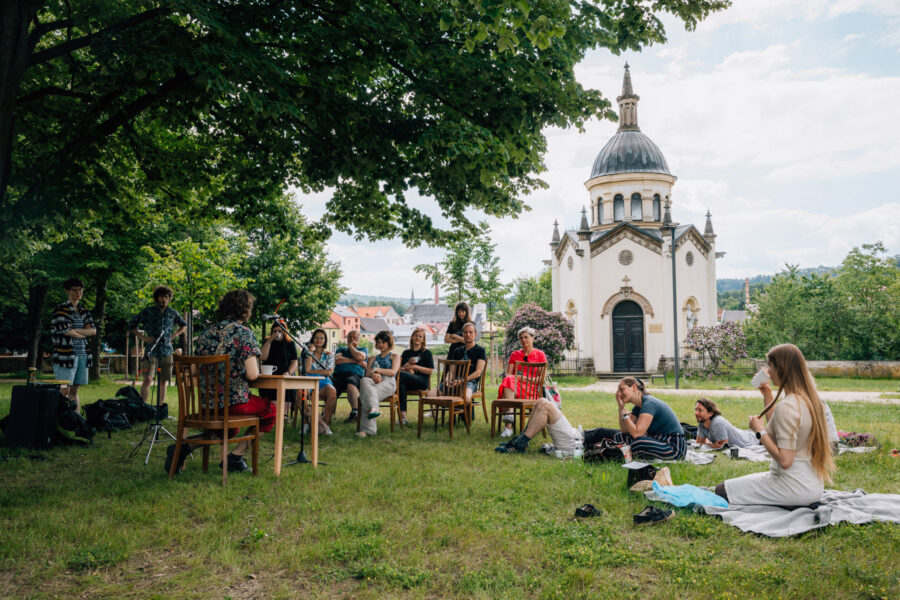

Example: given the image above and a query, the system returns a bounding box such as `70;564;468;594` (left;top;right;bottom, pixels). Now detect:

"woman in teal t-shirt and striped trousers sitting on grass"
584;377;687;460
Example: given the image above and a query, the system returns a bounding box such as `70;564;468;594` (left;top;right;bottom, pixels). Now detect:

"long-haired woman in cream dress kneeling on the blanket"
716;344;834;506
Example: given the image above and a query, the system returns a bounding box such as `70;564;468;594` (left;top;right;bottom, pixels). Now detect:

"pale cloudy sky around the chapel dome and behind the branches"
297;0;900;299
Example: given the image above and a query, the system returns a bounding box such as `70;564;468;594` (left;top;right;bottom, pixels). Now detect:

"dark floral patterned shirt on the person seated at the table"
196;319;261;406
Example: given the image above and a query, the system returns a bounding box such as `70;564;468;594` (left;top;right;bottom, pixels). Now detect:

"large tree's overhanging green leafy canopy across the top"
0;0;728;244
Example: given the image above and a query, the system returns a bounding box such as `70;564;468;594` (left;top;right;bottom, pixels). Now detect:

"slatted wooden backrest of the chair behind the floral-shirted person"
174;354;231;421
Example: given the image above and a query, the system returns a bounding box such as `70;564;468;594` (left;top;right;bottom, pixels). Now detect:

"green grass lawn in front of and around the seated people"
0;383;900;600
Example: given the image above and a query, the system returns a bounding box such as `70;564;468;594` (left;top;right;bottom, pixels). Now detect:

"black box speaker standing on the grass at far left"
6;385;61;449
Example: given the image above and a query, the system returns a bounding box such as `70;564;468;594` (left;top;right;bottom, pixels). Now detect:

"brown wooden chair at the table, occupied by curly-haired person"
169;354;260;486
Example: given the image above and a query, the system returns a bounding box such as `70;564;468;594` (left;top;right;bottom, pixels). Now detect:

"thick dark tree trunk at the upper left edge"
0;0;42;201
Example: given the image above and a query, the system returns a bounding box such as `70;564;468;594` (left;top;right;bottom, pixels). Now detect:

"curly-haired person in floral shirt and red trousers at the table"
166;290;275;472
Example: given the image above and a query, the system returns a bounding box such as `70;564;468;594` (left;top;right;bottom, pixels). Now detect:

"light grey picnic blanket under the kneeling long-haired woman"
694;489;900;537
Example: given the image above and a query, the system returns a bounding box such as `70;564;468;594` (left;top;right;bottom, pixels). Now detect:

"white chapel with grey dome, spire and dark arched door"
550;64;722;375
